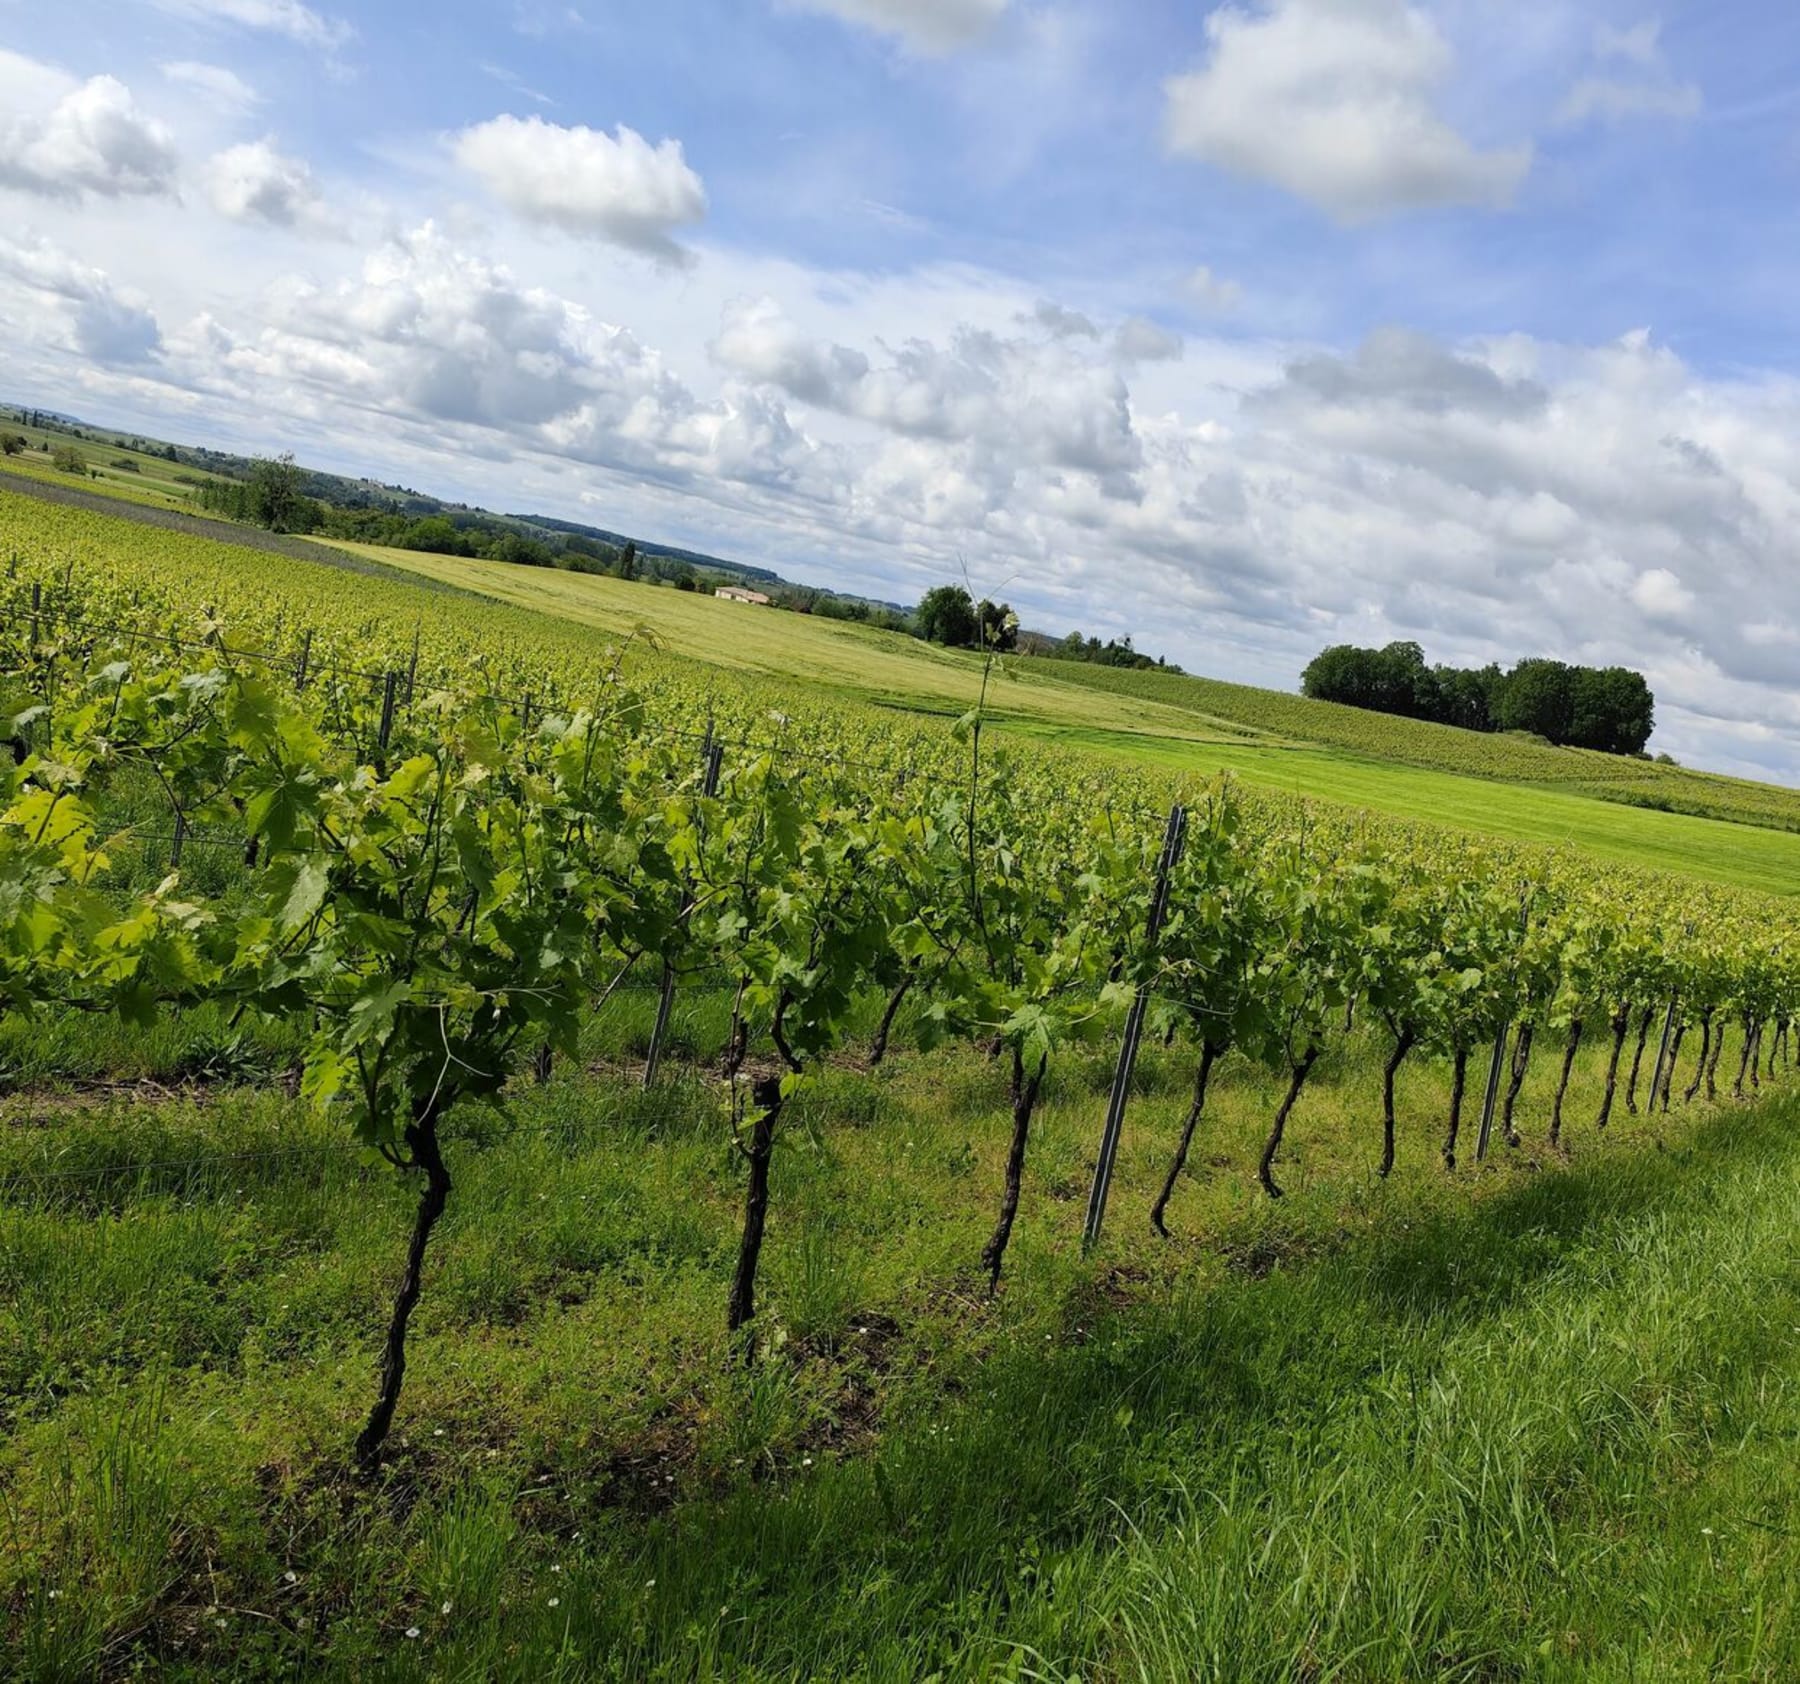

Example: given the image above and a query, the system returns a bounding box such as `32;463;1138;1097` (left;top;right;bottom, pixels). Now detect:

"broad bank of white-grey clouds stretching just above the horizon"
24;204;1800;770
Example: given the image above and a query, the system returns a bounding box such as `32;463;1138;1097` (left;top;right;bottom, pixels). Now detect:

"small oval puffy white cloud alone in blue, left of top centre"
454;117;706;261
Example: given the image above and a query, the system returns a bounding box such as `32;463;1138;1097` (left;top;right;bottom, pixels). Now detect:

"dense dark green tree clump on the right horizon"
1300;642;1656;754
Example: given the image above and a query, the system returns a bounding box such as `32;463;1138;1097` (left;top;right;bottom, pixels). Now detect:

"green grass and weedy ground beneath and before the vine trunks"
0;993;1800;1680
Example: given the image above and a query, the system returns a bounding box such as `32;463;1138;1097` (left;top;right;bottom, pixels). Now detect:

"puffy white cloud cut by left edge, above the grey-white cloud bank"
0;64;176;198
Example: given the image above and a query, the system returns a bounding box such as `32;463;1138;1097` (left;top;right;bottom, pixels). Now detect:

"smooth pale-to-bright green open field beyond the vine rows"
324;545;1800;894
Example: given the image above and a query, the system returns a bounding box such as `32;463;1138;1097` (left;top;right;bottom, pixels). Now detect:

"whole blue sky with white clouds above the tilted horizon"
0;0;1800;783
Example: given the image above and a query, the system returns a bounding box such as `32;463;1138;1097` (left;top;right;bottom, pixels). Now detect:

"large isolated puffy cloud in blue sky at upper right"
1166;0;1532;223
